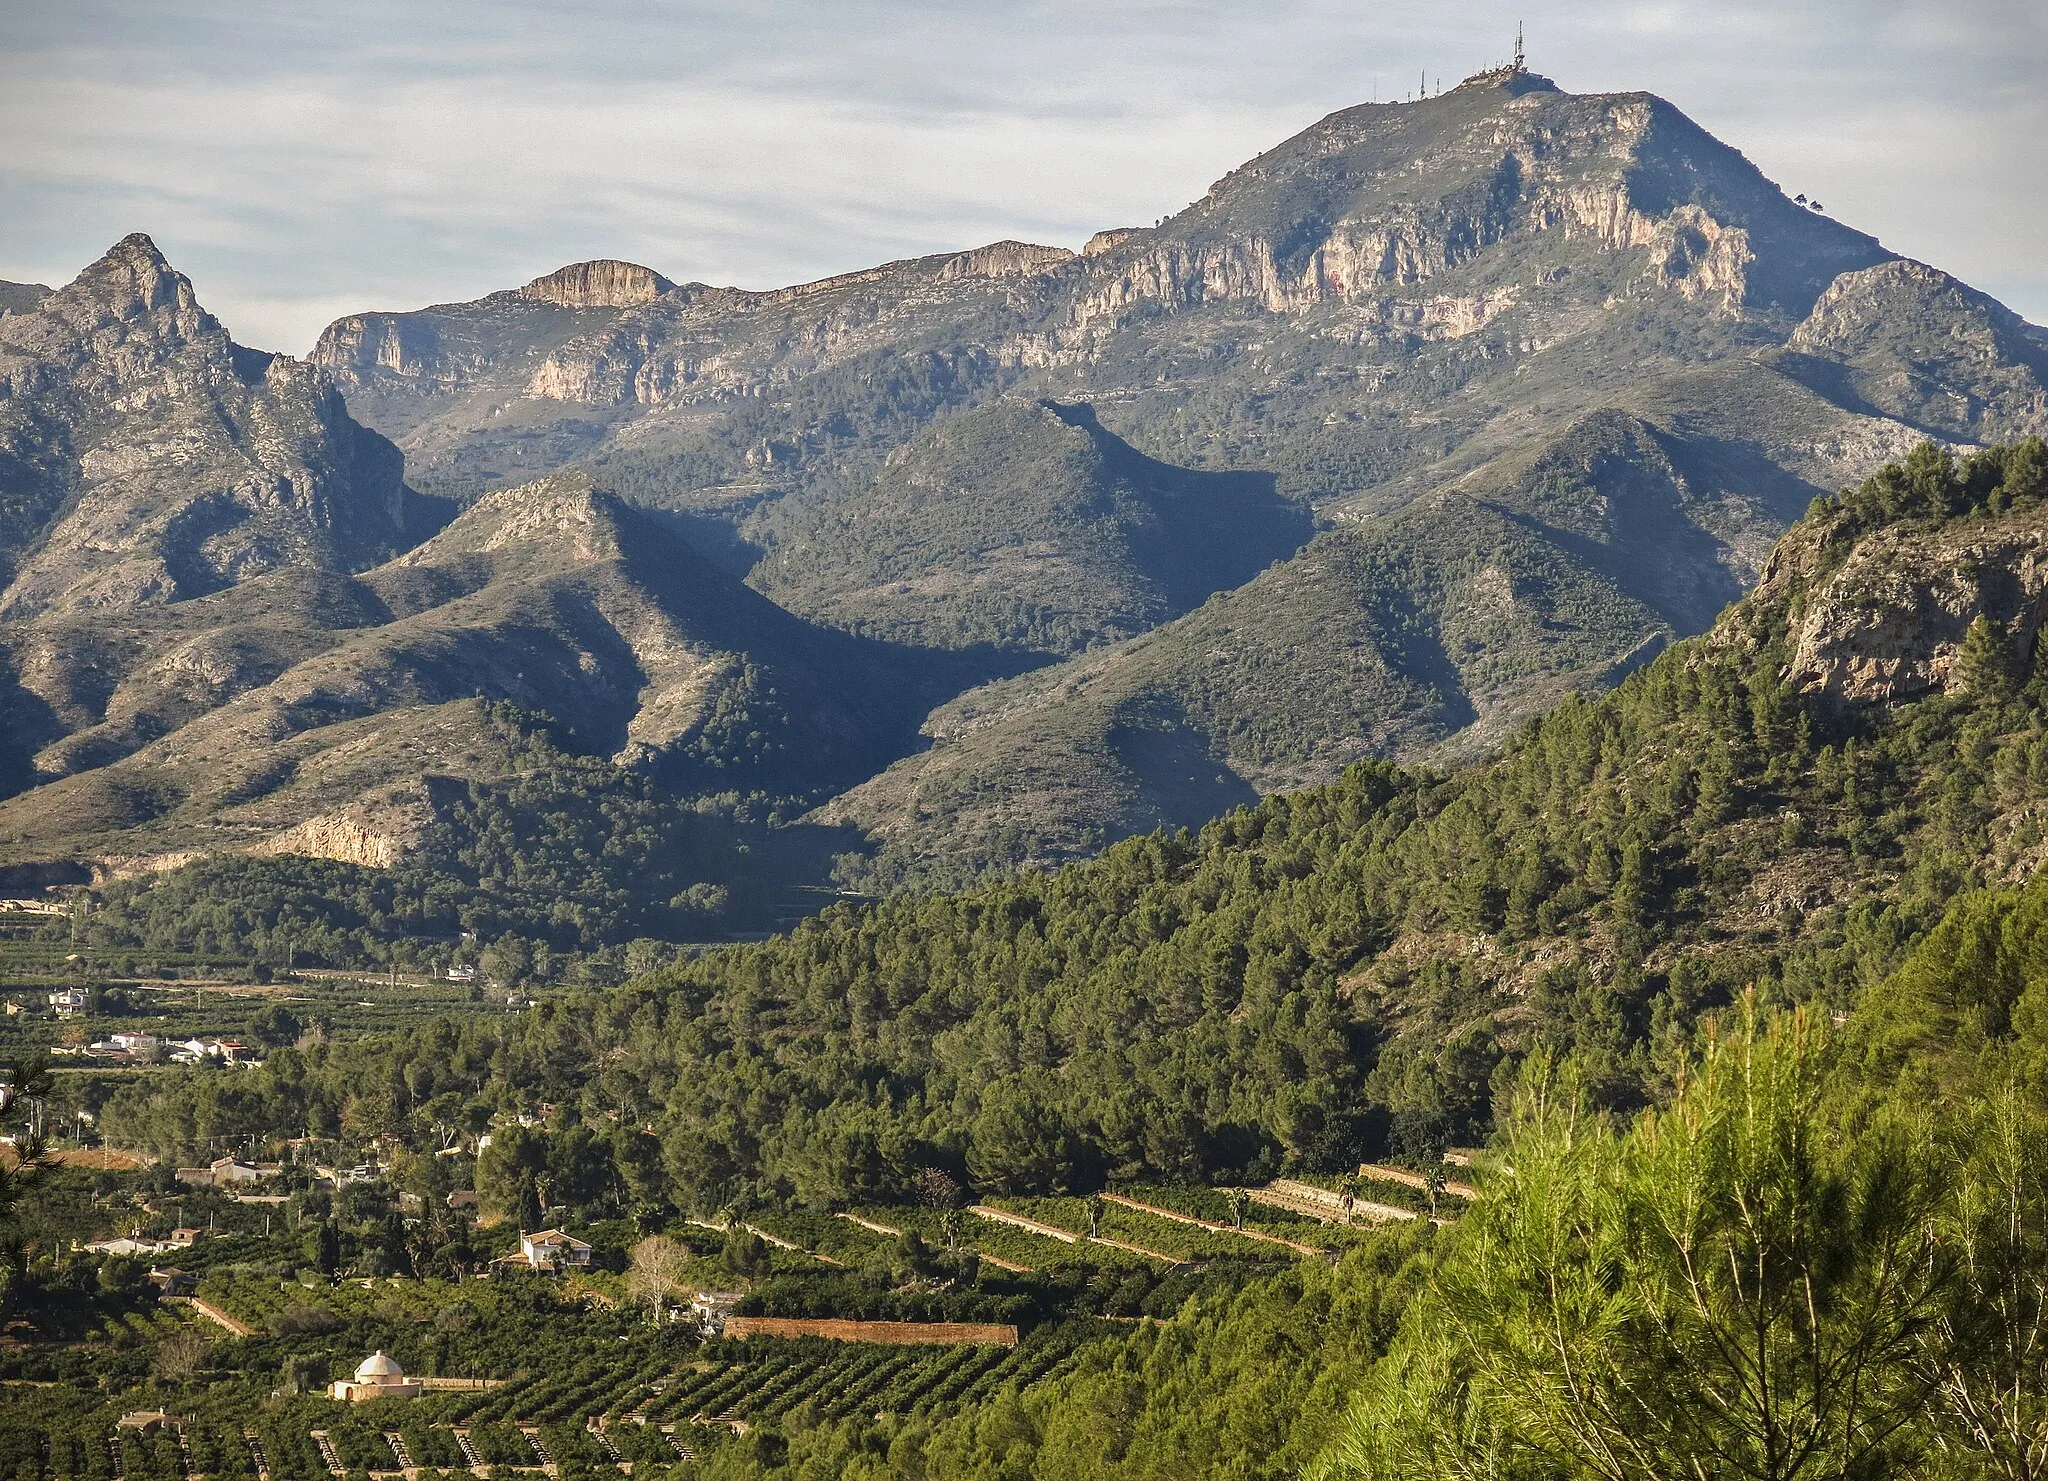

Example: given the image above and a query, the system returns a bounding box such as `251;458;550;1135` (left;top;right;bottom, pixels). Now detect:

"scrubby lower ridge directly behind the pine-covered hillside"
821;399;1916;883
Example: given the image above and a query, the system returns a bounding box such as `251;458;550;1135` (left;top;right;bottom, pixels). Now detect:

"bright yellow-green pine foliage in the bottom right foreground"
1333;1008;1954;1481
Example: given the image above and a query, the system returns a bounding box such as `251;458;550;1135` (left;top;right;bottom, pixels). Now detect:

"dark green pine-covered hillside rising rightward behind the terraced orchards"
99;442;2048;1179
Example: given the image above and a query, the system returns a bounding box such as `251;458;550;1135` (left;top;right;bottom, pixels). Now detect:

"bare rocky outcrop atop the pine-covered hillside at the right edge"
1761;510;2048;711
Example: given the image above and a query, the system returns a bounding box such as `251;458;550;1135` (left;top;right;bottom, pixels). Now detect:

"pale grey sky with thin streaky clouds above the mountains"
0;0;2048;354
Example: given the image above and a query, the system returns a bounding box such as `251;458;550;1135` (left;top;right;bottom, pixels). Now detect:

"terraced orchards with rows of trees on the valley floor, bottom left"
0;1186;1364;1481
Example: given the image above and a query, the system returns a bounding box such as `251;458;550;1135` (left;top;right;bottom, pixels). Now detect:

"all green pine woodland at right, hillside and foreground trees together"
72;442;2048;1479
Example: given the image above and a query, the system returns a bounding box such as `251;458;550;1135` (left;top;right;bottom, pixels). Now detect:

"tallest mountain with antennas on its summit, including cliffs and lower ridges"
299;72;2048;869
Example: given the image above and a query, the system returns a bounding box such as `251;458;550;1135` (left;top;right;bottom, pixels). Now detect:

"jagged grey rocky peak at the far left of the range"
0;234;406;621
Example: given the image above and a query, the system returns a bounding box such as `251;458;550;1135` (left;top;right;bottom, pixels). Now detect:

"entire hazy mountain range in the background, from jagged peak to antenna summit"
0;70;2048;905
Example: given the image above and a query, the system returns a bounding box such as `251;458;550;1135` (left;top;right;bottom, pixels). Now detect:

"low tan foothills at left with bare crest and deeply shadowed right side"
0;475;944;862
